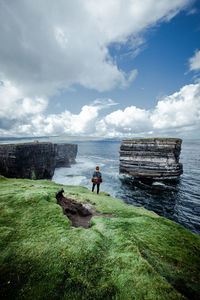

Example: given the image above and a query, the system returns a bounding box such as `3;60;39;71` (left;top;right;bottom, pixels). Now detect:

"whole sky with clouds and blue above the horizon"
0;0;200;138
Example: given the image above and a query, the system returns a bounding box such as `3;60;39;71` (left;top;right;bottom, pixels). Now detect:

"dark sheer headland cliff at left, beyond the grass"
0;143;77;179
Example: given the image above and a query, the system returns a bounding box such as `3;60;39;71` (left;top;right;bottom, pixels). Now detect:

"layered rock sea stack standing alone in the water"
120;138;183;178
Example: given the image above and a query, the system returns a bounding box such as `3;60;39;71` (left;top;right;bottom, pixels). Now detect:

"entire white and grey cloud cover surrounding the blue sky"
0;0;200;137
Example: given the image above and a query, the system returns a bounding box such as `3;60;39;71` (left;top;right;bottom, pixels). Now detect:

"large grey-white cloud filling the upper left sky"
0;0;191;96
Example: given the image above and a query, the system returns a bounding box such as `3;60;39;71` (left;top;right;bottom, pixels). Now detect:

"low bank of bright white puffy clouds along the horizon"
0;83;200;137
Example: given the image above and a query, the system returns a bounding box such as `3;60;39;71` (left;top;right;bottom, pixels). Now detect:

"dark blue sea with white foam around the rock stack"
0;137;200;235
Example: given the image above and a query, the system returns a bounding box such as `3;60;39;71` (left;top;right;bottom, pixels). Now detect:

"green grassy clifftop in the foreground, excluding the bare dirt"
0;176;200;300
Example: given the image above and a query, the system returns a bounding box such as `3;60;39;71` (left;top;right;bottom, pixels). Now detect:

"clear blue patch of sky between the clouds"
50;3;200;113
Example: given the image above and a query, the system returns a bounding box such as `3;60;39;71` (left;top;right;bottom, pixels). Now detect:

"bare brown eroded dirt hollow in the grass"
56;190;115;228
